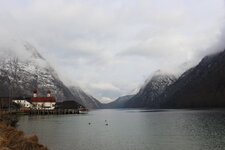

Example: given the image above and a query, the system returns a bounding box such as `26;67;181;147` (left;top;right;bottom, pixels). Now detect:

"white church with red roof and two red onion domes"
30;90;56;110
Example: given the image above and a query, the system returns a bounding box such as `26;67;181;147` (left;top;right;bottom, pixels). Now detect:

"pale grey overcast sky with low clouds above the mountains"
0;0;225;102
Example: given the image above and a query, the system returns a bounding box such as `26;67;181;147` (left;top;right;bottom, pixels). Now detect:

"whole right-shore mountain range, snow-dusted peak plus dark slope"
124;50;225;108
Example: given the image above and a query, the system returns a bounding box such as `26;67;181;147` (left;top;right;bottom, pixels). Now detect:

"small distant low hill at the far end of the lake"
102;95;134;109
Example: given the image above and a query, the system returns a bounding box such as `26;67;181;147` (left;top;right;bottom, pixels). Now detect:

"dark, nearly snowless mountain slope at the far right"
160;51;225;108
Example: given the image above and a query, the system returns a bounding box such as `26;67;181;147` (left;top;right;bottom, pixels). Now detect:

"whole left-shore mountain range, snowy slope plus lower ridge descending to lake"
0;42;100;108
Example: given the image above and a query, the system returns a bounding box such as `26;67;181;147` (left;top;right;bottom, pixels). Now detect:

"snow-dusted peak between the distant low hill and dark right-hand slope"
124;71;176;108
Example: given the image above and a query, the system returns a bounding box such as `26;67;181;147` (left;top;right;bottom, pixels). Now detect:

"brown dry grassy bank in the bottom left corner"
0;112;48;150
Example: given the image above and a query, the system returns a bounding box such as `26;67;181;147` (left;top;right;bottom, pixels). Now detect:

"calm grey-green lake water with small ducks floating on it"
18;109;225;150
